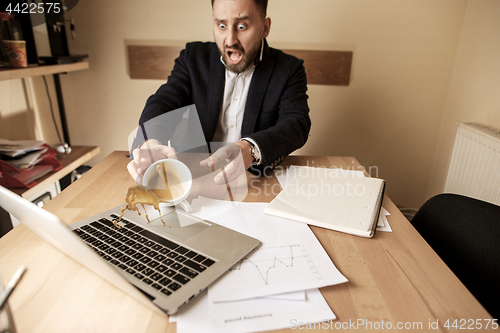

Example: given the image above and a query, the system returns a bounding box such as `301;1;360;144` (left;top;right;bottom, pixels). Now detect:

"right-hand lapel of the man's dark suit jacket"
241;40;275;137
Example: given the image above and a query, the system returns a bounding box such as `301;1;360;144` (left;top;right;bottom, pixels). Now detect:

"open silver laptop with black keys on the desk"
0;186;260;314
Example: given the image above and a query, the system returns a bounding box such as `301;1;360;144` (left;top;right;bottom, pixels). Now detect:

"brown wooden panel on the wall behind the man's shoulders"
127;45;352;86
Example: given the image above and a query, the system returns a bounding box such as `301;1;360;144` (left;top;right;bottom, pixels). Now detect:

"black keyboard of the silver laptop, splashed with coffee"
73;214;215;296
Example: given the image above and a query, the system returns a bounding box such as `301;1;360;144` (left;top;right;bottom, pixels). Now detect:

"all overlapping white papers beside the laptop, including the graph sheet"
171;198;347;333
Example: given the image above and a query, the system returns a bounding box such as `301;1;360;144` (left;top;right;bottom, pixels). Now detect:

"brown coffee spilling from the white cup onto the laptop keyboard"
114;163;183;228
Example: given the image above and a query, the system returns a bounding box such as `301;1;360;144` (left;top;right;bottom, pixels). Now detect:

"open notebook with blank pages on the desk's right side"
264;167;385;237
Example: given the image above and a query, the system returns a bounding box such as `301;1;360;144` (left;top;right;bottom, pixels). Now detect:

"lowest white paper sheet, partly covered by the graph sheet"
176;289;336;333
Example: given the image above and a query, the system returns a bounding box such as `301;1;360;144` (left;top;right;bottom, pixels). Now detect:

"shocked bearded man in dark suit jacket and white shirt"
128;0;311;183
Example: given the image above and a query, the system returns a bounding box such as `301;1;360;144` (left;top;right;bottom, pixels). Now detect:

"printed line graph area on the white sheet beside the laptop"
224;244;321;289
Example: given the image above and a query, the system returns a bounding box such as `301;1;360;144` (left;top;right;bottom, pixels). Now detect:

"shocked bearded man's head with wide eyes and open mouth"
213;0;271;73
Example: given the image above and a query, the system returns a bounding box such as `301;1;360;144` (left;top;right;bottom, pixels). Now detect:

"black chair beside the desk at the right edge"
411;194;500;319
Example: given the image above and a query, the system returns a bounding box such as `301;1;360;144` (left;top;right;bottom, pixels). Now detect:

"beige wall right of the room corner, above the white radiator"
427;0;500;197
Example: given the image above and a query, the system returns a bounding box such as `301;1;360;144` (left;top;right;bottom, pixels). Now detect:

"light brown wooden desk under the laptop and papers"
0;152;491;333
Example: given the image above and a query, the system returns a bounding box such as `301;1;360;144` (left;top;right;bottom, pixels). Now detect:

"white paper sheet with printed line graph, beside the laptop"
188;198;347;302
